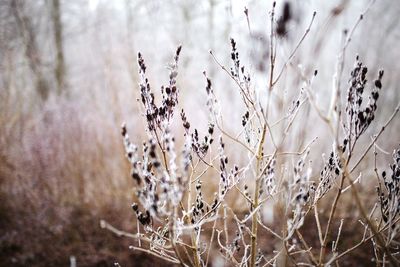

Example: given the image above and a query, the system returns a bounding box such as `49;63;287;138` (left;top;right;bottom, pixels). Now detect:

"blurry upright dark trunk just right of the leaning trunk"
51;0;65;94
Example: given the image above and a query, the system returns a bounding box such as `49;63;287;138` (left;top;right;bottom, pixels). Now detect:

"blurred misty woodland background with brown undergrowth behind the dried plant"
0;0;400;266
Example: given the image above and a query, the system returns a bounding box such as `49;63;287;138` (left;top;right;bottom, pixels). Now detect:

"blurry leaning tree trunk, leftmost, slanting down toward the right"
11;0;49;100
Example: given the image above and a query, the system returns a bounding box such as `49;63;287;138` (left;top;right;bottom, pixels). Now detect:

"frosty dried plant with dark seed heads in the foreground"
102;3;400;267
